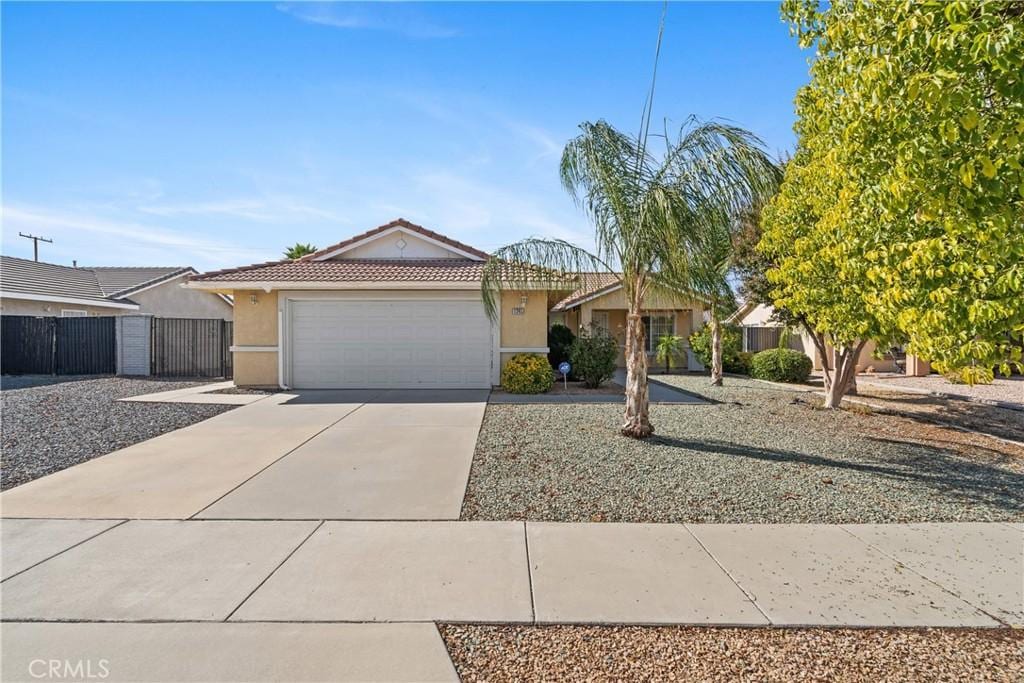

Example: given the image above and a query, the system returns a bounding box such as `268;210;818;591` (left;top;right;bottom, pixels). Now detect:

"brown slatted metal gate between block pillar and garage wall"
150;317;231;378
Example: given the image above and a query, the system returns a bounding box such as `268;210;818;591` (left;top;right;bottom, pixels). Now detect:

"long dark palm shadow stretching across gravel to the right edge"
649;436;1024;512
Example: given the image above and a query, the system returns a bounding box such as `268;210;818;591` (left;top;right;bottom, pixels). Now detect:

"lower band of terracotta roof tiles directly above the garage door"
193;258;483;283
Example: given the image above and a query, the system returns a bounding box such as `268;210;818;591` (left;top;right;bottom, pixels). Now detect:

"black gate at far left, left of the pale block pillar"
0;315;117;375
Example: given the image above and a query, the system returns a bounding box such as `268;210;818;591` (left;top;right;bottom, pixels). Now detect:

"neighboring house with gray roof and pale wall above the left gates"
0;256;232;321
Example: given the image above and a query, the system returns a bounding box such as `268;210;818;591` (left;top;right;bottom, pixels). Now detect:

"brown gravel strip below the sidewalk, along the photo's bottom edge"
439;625;1024;683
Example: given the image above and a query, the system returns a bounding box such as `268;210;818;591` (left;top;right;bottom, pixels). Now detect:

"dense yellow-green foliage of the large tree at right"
761;0;1024;381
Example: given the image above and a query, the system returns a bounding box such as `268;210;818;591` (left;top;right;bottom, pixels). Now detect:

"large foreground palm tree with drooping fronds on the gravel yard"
481;118;771;438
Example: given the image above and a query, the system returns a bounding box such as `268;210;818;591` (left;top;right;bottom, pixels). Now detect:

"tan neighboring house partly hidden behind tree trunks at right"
727;302;932;376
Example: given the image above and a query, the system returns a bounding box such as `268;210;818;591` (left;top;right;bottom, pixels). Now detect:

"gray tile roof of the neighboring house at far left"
0;256;195;303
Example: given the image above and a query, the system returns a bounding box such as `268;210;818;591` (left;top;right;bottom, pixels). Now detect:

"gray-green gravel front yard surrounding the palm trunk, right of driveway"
462;376;1024;523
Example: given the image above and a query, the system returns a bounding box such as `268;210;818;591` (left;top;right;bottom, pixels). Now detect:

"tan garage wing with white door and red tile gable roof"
188;219;564;388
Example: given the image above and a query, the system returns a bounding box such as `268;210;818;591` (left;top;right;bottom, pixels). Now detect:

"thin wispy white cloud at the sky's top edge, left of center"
276;2;459;39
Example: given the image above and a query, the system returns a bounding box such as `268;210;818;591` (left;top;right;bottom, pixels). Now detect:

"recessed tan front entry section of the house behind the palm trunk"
549;272;707;372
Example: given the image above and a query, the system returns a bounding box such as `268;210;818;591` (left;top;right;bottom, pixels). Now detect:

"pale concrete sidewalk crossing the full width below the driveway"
2;519;1024;627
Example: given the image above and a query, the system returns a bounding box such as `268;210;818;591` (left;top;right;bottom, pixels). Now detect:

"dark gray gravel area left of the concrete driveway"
0;377;234;488
